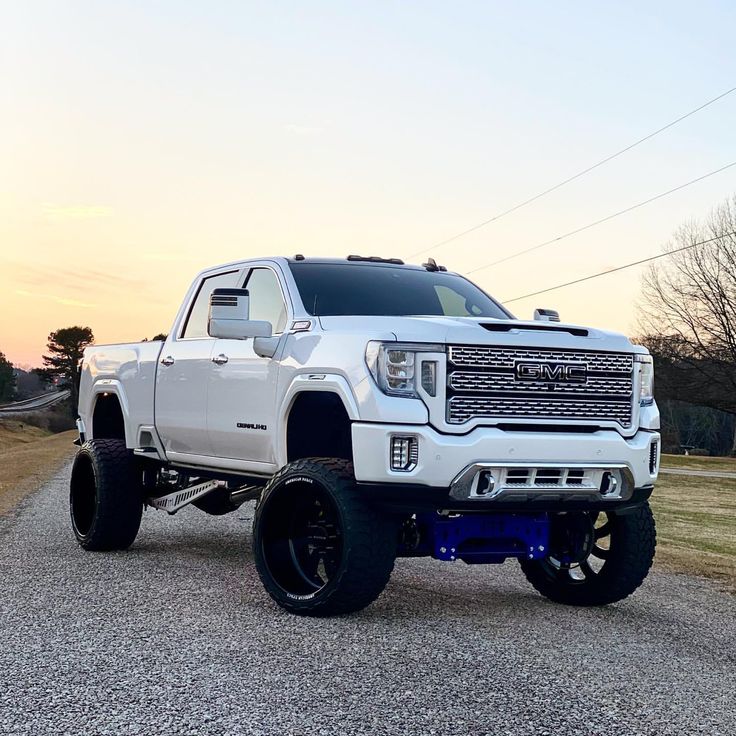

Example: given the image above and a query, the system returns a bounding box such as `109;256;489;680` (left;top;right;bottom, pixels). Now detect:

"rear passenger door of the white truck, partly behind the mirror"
155;269;242;460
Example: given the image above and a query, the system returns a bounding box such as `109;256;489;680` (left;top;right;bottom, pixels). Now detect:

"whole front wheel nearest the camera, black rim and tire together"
253;458;398;616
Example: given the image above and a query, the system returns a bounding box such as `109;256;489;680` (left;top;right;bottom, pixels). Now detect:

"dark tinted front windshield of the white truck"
289;262;510;319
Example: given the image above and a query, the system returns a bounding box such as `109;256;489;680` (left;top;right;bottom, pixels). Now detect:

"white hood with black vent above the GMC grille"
319;316;647;353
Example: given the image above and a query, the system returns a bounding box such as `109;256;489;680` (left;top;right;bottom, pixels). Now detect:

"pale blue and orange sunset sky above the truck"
0;0;736;365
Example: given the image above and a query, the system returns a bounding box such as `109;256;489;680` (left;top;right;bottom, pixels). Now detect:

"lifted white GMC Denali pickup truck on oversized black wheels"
70;255;660;616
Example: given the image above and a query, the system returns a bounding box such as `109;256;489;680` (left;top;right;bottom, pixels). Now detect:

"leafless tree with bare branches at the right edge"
640;196;736;450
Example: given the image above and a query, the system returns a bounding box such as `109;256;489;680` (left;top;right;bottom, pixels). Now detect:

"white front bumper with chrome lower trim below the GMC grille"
352;423;660;501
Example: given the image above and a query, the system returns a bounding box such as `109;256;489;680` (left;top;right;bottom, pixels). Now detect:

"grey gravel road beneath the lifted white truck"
0;469;736;736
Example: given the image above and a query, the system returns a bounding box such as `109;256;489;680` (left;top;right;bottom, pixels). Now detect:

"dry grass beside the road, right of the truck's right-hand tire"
652;472;736;591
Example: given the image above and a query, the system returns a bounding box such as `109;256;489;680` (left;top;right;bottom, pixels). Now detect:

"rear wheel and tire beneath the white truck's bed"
69;440;143;550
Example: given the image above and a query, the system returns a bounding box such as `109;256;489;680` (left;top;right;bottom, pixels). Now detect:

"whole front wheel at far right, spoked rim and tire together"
521;503;656;606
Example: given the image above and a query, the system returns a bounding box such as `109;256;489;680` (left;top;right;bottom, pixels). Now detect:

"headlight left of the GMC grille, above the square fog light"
365;341;444;397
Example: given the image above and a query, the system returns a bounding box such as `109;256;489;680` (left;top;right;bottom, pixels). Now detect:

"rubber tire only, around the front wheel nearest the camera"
253;458;398;616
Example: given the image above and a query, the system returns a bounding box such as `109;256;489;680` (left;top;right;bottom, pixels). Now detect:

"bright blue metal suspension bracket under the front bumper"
417;513;550;564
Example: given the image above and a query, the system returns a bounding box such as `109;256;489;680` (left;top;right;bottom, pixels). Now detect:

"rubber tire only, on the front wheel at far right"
521;502;657;606
